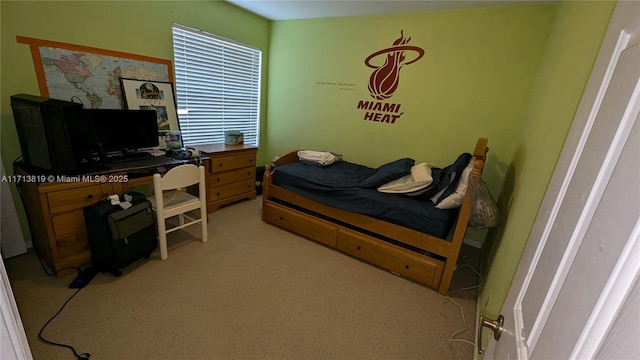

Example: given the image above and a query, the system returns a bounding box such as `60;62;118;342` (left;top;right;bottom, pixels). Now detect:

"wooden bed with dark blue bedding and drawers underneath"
262;138;488;295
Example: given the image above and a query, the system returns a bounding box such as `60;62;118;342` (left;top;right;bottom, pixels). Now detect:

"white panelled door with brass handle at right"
485;1;640;359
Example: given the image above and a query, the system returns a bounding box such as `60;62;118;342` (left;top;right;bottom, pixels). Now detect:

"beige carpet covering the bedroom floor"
6;197;477;360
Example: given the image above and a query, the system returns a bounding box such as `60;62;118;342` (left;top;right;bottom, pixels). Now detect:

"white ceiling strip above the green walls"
222;0;552;20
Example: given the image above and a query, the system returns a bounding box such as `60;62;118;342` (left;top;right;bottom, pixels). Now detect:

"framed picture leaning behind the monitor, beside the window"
120;78;180;133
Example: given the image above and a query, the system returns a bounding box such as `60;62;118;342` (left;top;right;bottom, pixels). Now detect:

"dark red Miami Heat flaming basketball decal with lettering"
358;31;424;124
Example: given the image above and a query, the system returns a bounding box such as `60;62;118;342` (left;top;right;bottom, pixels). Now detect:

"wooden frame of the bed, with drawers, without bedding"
262;138;488;295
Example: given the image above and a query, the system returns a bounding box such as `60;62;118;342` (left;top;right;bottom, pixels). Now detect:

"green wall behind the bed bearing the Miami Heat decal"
266;5;556;211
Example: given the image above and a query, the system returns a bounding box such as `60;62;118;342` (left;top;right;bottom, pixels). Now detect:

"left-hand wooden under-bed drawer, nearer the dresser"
265;204;337;248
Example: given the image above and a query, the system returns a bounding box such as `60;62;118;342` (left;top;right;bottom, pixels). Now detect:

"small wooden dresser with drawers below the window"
191;144;258;213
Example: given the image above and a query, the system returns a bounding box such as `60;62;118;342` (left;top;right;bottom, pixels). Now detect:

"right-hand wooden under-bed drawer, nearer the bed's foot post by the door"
337;228;444;289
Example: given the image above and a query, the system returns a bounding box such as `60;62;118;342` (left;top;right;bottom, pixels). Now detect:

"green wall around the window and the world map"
0;0;271;242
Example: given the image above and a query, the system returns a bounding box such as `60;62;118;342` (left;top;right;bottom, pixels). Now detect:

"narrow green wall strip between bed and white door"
479;1;615;317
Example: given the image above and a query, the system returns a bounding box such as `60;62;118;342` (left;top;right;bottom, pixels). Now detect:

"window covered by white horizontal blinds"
173;24;262;146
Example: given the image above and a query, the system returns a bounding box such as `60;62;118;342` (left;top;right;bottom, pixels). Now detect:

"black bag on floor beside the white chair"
84;192;158;276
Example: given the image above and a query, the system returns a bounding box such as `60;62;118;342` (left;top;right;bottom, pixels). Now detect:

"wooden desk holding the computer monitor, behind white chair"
15;157;209;276
